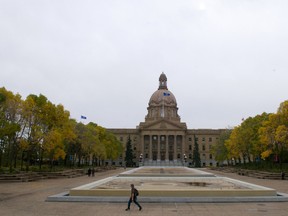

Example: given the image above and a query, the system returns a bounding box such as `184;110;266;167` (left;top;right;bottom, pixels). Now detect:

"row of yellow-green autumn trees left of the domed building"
0;88;123;171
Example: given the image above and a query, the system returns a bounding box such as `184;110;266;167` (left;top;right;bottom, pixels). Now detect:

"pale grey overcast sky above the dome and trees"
0;0;288;129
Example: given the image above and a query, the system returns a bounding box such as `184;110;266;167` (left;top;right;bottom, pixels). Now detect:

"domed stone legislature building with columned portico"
107;73;222;166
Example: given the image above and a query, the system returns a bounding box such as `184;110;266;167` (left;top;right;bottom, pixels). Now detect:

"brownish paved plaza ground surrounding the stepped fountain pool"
0;169;288;216
